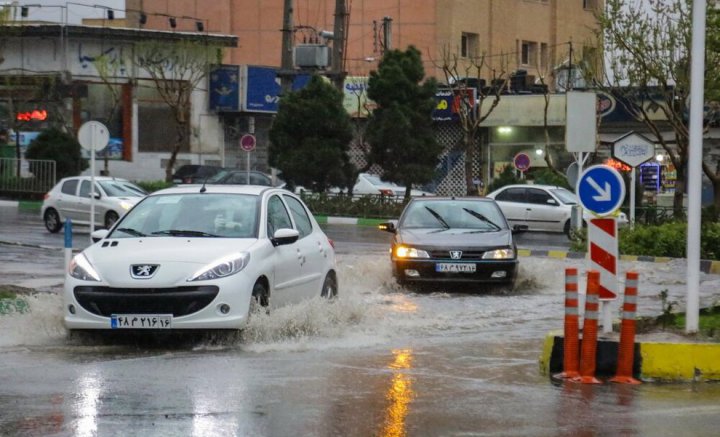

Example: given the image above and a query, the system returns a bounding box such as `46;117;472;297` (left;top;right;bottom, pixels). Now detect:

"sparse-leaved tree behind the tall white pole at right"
594;0;720;212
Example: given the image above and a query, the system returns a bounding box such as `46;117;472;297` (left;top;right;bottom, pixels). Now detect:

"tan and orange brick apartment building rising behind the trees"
126;0;604;83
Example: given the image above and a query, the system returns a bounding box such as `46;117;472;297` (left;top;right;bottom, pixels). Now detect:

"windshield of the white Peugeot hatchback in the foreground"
109;193;258;238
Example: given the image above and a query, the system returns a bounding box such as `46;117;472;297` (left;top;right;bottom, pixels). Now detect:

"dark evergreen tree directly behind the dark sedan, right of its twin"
367;46;442;200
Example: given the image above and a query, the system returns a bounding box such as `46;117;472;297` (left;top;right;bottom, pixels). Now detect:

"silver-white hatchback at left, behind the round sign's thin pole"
40;176;147;233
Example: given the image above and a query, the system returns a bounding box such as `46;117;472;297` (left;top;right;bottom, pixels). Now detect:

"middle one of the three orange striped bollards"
572;270;600;384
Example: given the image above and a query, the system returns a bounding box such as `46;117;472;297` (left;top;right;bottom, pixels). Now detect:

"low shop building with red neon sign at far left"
0;18;237;180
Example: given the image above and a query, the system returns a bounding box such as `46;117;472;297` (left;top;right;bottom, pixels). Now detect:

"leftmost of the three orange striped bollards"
554;268;580;379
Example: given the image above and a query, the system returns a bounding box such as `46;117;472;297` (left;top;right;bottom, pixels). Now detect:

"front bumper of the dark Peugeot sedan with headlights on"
392;259;519;284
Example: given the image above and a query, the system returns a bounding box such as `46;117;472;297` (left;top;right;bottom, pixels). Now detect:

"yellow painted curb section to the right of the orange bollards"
640;343;720;381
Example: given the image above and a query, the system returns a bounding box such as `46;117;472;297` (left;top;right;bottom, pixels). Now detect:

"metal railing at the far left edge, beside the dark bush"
0;158;57;194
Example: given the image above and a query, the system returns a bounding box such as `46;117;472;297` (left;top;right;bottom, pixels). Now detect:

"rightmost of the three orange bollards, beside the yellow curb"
610;272;640;384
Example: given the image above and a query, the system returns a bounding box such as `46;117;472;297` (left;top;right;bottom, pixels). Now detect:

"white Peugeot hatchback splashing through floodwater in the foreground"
64;185;338;331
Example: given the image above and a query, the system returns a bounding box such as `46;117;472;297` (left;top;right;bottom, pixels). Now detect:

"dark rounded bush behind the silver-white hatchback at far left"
25;128;88;179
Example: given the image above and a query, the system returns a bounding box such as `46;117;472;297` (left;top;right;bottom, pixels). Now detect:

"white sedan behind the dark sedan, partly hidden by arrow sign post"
487;184;628;234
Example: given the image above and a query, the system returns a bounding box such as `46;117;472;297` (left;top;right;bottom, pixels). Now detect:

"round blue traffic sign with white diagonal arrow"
575;165;625;216
